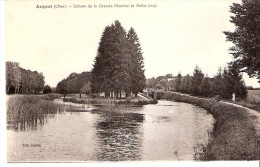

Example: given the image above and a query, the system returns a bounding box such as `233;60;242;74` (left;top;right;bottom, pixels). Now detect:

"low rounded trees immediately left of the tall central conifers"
56;72;91;95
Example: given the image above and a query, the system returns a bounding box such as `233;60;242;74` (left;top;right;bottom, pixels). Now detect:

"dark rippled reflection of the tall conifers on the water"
93;107;144;161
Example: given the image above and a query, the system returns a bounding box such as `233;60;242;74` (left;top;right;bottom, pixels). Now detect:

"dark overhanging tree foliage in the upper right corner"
224;0;260;82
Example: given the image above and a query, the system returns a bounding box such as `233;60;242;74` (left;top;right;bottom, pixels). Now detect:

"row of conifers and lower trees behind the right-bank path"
146;62;247;99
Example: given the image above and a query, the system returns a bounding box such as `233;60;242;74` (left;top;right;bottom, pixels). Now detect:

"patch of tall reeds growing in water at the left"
7;95;62;129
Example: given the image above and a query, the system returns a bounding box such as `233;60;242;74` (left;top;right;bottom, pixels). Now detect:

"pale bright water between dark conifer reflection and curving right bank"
142;101;214;161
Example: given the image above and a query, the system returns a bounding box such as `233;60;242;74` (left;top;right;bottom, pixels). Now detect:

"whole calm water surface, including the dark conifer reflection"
7;101;214;162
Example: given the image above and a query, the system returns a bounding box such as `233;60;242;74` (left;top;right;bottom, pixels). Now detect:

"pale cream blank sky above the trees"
5;0;260;87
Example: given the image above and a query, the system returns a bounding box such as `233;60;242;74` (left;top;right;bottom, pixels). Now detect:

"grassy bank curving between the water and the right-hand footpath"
157;92;260;161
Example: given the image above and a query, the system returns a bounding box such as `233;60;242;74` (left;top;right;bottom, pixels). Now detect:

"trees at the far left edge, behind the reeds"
6;61;45;94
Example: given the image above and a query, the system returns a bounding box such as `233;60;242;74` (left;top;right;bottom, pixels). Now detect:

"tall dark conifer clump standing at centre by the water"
91;21;145;97
